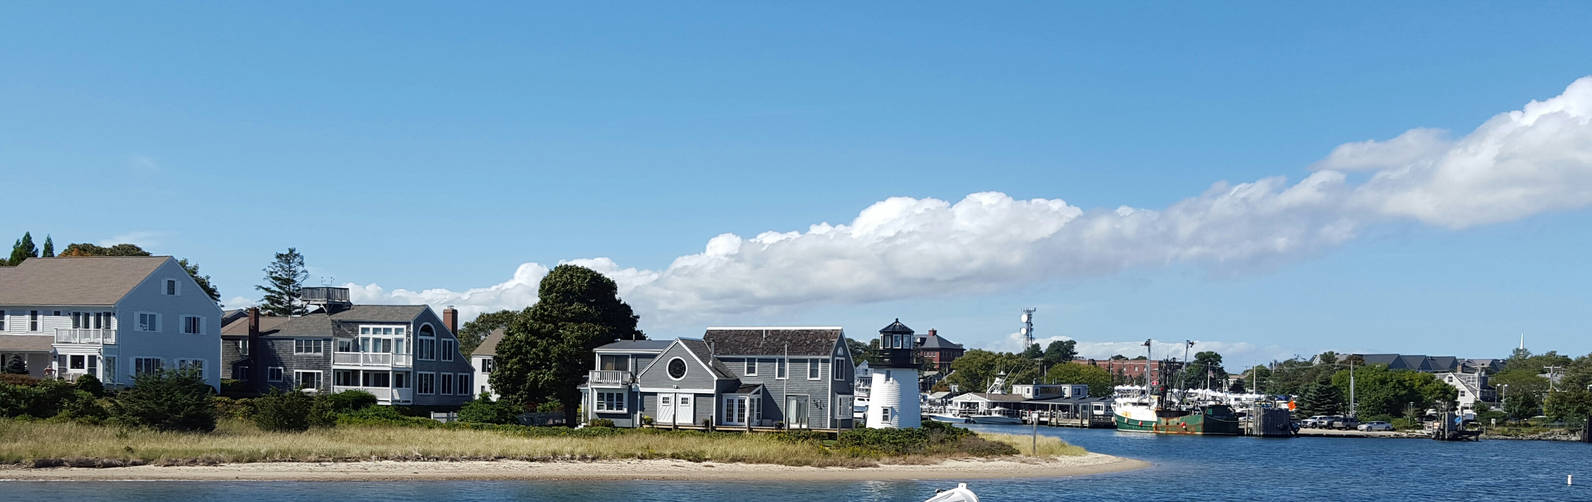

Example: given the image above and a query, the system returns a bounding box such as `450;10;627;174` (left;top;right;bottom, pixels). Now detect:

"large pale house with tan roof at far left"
0;257;221;389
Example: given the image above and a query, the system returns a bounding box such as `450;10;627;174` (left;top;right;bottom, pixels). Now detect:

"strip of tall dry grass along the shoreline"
0;419;1086;467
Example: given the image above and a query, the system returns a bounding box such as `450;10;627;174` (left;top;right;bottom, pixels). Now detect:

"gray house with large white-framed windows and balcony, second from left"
221;287;476;408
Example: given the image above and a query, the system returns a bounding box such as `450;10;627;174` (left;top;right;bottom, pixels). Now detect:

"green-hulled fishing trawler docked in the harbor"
1111;339;1239;435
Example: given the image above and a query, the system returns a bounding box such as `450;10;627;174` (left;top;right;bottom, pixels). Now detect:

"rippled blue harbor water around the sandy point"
0;426;1592;502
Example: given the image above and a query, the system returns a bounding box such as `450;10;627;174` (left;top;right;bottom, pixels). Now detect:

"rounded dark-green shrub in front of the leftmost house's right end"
113;370;215;432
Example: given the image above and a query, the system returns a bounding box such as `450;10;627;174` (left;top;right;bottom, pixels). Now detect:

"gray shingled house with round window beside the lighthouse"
581;327;855;430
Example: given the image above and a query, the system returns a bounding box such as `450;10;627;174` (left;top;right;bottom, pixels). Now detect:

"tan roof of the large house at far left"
0;257;172;306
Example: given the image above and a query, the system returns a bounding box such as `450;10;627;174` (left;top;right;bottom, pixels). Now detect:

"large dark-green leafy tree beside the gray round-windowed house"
490;265;646;424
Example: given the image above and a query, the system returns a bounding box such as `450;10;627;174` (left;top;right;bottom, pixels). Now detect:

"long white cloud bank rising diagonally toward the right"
350;76;1592;345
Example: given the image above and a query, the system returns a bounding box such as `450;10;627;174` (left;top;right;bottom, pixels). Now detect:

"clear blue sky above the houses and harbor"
0;3;1592;369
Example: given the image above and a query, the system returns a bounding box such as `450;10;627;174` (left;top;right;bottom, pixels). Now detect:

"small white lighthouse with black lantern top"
868;319;923;429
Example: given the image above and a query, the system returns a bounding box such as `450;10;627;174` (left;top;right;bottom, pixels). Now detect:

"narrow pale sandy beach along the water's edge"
0;453;1149;481
